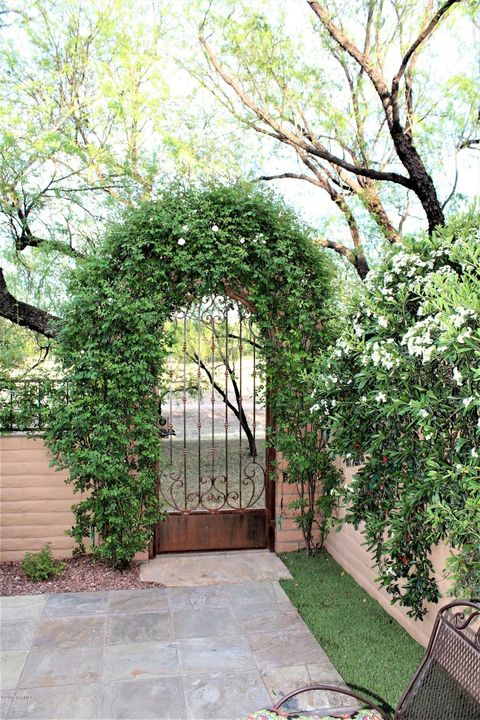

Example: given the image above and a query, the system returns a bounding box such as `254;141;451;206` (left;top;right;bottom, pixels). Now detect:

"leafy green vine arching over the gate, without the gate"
47;185;331;565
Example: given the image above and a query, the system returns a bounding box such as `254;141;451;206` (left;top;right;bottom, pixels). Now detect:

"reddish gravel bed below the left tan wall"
0;555;162;595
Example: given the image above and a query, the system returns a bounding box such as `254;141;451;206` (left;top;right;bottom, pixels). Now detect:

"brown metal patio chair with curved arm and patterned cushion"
244;601;480;720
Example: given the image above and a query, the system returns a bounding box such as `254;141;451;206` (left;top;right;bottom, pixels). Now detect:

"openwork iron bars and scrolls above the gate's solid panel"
160;296;265;513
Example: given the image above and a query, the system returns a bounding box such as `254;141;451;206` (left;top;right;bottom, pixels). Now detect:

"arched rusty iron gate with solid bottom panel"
155;296;274;553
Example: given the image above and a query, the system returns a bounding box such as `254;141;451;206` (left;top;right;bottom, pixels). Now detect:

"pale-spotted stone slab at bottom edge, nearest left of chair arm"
183;670;270;720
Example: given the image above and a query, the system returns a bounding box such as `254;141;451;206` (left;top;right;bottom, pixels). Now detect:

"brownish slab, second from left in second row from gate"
33;616;107;648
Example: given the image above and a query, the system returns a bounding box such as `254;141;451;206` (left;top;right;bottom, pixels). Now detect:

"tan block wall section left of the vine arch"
0;434;74;561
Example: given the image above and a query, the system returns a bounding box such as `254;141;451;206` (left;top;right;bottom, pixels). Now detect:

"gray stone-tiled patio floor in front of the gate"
0;556;348;720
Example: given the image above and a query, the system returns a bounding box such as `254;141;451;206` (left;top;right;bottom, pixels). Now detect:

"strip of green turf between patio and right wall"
281;552;424;707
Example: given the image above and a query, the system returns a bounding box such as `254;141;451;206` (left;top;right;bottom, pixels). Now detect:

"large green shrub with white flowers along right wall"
312;215;480;618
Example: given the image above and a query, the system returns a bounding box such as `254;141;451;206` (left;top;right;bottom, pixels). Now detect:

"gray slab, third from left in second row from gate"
105;612;173;645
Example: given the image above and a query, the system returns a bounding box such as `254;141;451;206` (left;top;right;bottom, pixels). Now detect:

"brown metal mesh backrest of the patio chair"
395;601;480;720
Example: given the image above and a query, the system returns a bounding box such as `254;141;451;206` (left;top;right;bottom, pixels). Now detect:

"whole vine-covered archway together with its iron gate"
47;186;330;565
